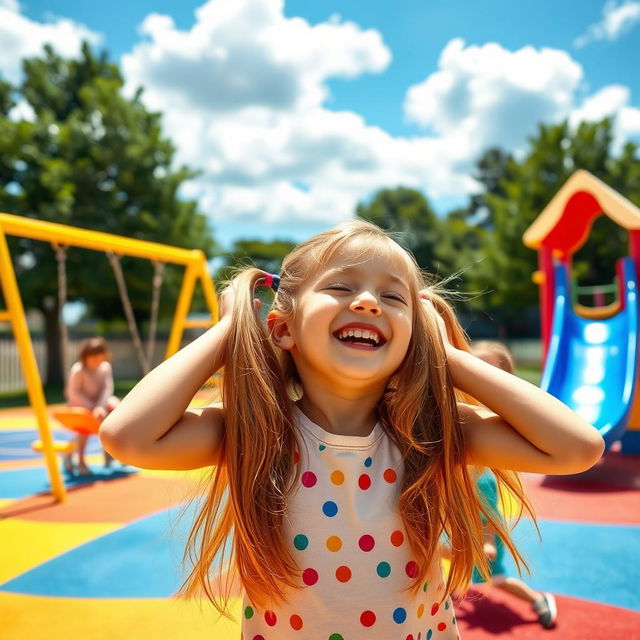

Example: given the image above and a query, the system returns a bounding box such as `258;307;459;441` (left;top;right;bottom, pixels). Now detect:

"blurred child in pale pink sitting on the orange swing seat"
65;336;119;475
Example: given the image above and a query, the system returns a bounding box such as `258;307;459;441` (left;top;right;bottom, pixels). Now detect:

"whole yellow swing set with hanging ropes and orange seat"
0;213;218;502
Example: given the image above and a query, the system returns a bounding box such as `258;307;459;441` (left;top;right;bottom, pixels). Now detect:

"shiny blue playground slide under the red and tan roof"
540;258;638;447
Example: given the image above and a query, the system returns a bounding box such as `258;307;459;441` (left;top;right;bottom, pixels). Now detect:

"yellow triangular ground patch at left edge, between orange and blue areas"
0;518;122;584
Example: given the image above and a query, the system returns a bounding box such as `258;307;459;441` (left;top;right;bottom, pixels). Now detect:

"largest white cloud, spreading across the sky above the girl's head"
122;0;475;228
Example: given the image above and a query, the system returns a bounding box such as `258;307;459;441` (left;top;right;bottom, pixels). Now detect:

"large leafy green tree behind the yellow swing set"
0;43;214;383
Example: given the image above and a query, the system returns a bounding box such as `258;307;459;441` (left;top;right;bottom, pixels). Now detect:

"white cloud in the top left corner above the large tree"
0;0;101;83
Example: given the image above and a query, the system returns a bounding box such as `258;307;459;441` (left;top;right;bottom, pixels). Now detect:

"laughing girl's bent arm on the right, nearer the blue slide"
445;344;604;474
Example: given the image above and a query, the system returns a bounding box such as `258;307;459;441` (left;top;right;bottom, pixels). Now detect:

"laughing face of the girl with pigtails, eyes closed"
282;252;413;388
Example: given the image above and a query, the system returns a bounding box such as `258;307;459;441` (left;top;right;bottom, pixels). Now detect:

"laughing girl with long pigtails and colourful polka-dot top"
100;221;603;640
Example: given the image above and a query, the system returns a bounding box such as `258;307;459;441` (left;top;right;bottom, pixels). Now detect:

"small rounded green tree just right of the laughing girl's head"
356;187;442;273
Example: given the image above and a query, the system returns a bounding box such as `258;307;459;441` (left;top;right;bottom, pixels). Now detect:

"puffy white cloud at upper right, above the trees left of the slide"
405;39;583;159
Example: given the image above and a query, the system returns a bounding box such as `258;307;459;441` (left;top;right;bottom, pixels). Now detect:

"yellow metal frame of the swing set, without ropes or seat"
0;213;218;502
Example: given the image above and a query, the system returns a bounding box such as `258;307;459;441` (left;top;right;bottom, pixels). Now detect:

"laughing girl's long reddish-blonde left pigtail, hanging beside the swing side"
183;268;296;615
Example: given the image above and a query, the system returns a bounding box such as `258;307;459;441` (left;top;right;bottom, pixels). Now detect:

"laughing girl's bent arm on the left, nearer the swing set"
100;316;230;469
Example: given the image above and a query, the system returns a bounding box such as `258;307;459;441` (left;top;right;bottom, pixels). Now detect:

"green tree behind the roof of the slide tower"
469;119;640;332
